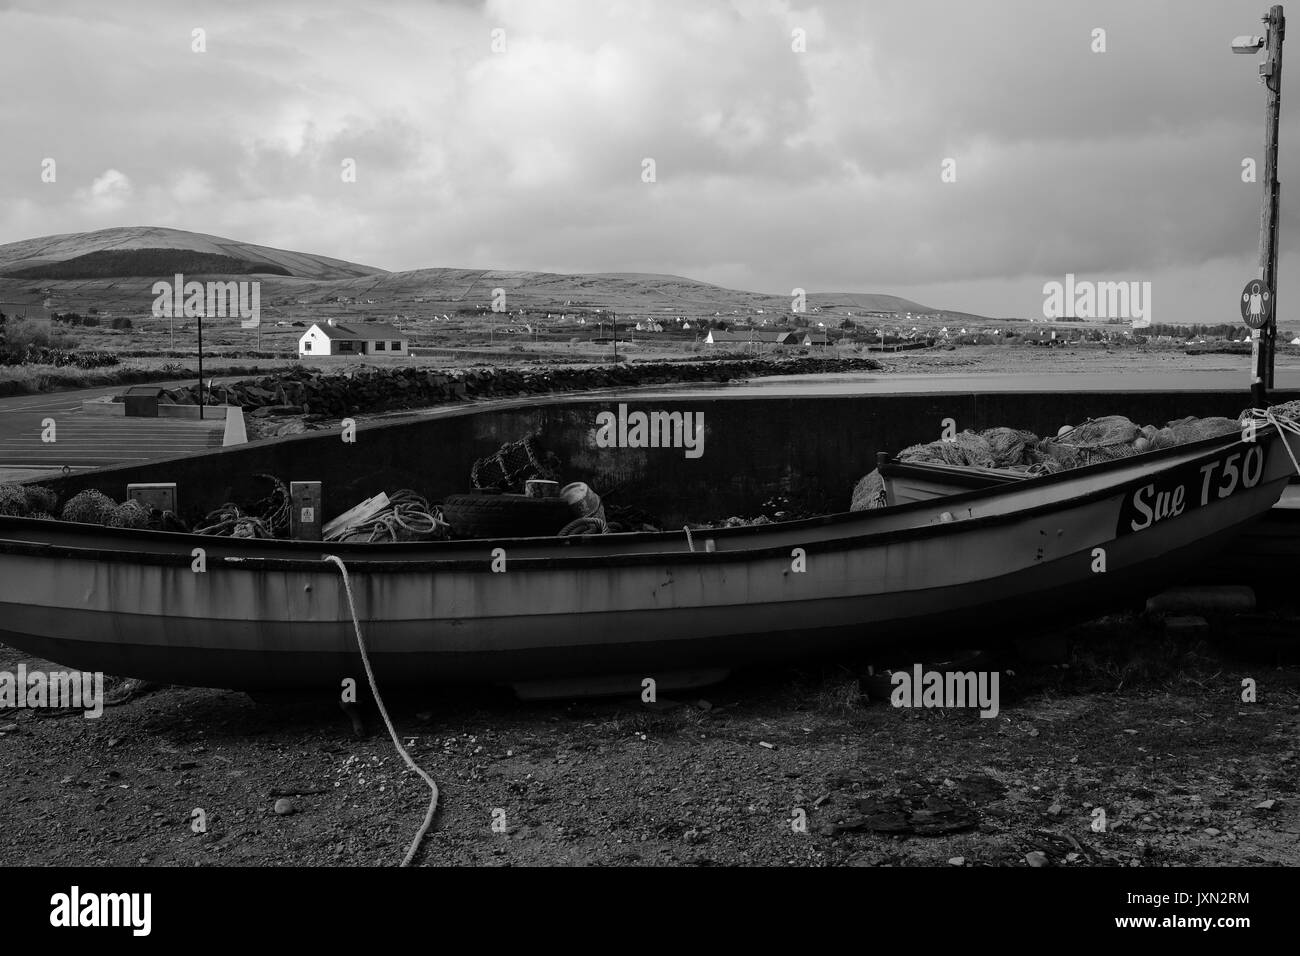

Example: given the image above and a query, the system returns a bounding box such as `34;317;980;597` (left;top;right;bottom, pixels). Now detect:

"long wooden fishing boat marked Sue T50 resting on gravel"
0;424;1300;692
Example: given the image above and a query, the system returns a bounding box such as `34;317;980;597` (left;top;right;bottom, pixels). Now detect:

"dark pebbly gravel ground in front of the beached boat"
0;626;1300;866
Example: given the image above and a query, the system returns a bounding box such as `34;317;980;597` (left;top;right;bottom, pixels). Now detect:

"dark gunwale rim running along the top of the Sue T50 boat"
0;424;1286;574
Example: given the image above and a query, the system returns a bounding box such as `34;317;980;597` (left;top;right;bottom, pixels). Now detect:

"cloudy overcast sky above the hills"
0;0;1300;323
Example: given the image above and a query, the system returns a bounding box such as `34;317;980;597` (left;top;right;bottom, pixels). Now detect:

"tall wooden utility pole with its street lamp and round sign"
1232;4;1286;408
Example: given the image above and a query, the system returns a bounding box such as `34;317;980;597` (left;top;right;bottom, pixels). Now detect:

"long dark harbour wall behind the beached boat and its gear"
27;388;1292;528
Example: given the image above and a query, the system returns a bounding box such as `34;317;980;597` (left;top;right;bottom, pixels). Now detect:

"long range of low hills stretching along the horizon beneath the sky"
0;226;982;323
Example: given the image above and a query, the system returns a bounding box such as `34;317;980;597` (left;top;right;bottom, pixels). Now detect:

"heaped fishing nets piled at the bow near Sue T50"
849;416;1242;511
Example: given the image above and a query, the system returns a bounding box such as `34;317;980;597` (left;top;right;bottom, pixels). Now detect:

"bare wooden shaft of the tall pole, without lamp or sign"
1251;4;1286;408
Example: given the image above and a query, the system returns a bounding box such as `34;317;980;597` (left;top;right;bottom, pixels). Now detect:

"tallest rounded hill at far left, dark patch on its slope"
0;226;385;280
